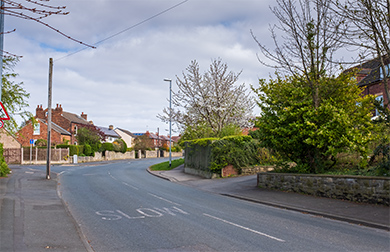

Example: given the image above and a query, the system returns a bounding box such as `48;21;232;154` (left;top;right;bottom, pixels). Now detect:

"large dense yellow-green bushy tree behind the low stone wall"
254;74;373;173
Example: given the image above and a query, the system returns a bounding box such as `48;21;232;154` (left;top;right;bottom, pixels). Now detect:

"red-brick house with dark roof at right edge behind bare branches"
351;57;390;116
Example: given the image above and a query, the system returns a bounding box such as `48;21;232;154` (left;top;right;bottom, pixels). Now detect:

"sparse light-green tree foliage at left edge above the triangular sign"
1;57;33;133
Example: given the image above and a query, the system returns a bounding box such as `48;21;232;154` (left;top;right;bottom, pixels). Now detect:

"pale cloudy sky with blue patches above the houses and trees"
4;0;277;135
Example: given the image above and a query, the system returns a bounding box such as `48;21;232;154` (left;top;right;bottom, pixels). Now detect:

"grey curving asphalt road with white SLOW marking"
55;159;390;251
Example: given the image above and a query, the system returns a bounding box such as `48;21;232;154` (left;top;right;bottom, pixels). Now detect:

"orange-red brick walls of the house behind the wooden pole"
17;118;72;147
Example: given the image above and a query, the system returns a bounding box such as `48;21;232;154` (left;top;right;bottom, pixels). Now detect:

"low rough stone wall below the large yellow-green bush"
257;173;390;206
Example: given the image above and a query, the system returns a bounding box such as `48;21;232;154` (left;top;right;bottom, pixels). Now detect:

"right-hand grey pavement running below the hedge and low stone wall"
149;166;390;231
